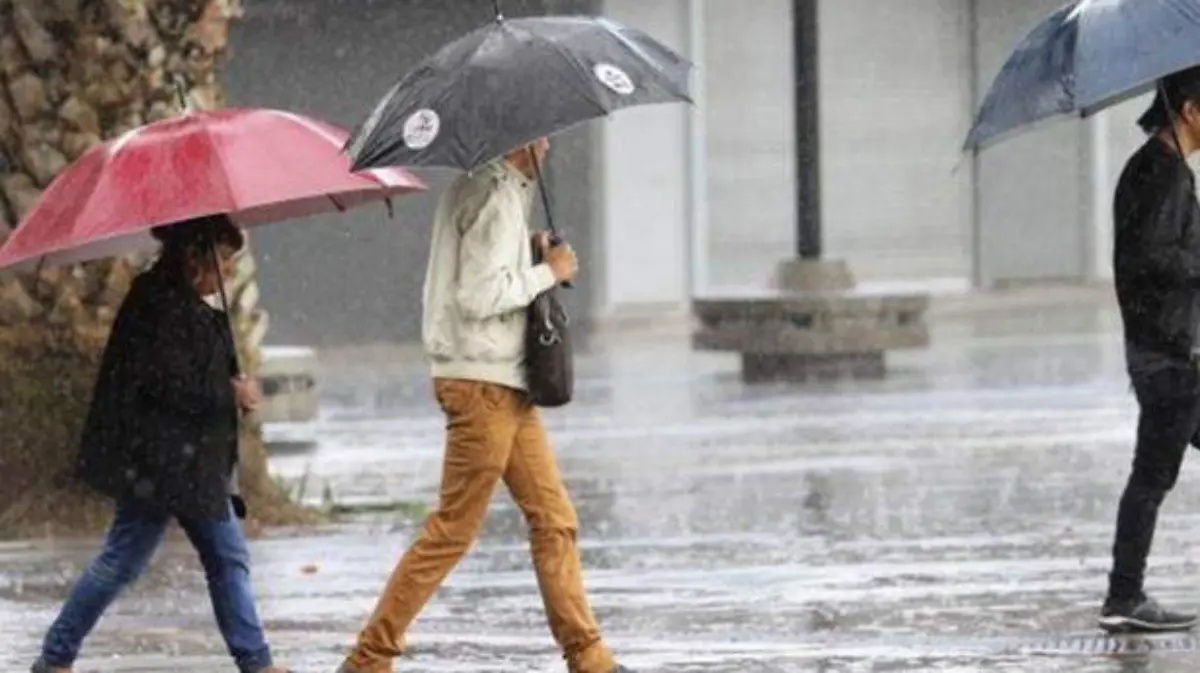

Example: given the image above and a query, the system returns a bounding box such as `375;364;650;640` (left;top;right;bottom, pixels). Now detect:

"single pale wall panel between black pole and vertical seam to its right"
817;0;974;281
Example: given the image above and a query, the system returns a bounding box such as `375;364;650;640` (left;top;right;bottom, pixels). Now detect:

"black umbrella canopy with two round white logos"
347;17;691;170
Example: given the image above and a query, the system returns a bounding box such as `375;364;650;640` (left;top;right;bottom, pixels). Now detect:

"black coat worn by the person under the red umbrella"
77;265;238;518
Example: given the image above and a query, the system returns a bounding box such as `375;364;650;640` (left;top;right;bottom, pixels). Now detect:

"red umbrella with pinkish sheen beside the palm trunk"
0;108;426;269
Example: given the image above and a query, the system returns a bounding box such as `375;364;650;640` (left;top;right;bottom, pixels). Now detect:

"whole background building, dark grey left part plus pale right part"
228;0;1146;343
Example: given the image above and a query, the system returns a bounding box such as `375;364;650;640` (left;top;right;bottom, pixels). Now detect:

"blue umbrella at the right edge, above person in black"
965;0;1200;150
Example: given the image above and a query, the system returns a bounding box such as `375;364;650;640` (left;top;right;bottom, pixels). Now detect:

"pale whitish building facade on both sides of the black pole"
594;0;1147;314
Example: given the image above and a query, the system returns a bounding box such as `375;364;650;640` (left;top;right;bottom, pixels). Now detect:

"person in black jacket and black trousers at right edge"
1099;68;1200;632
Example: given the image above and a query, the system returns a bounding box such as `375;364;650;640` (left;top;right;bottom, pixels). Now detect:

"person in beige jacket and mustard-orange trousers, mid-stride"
341;139;630;673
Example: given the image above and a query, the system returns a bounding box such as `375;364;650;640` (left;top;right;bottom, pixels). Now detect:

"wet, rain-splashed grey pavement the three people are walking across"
0;295;1200;673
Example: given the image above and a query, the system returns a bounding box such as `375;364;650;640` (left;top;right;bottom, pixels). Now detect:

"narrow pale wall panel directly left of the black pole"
700;0;796;288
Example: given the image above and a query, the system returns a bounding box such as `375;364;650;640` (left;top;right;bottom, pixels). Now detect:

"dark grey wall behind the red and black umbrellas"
224;0;601;345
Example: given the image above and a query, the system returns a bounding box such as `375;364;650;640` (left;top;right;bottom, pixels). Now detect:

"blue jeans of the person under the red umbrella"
42;504;271;673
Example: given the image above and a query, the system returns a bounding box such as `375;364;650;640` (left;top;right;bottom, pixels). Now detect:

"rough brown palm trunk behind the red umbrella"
0;0;306;535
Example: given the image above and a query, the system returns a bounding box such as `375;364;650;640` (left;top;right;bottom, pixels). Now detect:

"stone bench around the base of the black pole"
692;257;929;383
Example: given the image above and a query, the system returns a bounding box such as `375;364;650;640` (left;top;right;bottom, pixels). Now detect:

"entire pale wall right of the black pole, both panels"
818;0;1148;287
